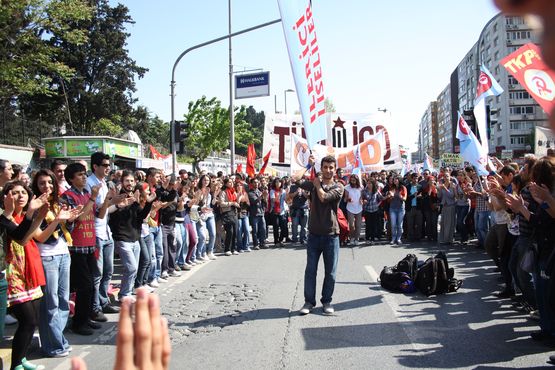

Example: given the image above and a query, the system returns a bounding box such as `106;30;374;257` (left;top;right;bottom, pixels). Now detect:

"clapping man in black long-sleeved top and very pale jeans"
109;171;156;301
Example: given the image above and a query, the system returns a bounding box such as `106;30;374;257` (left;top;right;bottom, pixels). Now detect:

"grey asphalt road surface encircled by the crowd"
30;238;553;370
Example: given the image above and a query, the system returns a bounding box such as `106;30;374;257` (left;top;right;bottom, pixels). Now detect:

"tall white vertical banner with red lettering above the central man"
278;0;327;148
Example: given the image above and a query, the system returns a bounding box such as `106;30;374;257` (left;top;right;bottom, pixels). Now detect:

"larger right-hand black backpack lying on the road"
416;252;462;296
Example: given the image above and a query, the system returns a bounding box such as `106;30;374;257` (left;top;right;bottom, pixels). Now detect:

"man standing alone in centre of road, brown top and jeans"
294;155;344;315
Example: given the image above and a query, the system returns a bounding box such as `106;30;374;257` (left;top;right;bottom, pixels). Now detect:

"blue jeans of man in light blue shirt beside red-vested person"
93;238;114;311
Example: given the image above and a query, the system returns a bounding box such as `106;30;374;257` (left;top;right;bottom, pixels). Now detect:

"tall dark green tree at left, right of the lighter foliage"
17;0;147;134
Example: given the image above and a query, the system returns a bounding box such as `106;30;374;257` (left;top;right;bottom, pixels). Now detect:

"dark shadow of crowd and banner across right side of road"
302;246;550;369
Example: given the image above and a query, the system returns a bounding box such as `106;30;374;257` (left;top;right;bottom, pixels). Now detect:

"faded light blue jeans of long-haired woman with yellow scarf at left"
39;253;71;356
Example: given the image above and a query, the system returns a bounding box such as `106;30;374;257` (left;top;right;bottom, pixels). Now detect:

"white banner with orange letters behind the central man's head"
291;131;385;175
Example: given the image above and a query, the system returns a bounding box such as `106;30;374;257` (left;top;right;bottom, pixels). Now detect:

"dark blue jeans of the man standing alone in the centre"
304;234;339;306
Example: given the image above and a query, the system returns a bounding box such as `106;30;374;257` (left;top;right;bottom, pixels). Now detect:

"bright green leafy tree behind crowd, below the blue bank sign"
184;96;260;172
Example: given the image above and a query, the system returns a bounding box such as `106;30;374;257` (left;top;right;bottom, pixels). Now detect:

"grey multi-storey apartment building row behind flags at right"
418;14;548;158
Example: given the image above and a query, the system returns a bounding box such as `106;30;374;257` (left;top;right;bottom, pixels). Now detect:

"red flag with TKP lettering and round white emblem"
500;43;555;114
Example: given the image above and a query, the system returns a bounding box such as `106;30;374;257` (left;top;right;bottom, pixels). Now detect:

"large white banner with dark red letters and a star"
263;113;403;170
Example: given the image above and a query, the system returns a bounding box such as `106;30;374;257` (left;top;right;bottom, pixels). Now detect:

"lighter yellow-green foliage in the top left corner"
0;0;92;99
